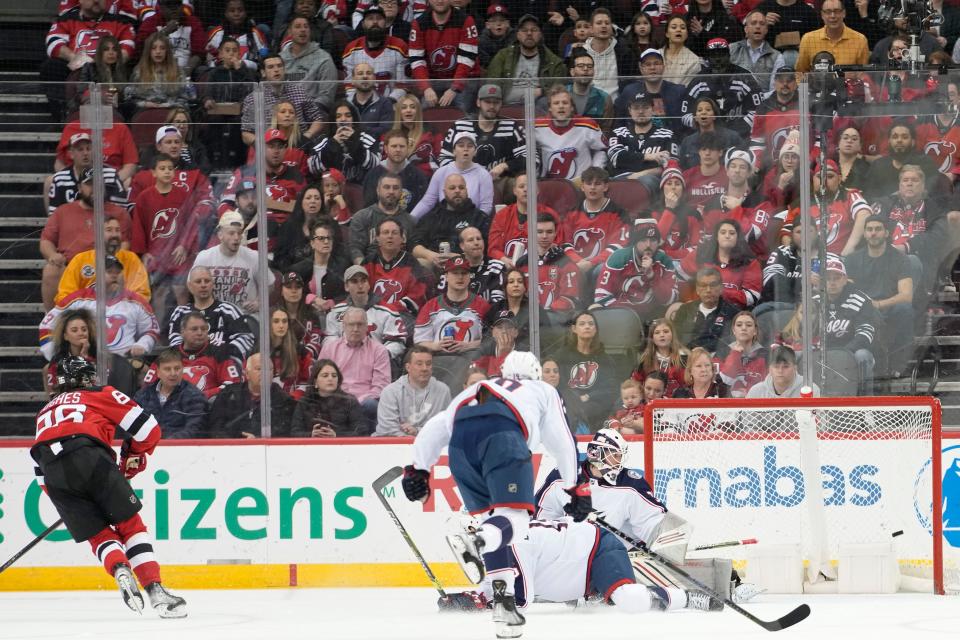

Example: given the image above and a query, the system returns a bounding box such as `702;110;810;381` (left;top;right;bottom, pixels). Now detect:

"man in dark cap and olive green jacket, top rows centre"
487;14;567;104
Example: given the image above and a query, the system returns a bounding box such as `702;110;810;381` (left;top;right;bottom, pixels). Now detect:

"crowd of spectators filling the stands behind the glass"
31;0;960;438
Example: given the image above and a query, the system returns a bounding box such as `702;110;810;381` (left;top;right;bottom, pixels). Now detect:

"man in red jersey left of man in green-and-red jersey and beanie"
517;213;581;321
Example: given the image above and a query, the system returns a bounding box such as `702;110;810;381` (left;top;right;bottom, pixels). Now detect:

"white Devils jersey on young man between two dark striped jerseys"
534;116;607;180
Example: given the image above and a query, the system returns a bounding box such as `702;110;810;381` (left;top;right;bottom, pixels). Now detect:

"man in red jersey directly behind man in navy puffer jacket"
143;311;242;400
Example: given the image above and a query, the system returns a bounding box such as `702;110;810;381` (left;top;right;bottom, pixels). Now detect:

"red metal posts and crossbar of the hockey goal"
643;396;944;595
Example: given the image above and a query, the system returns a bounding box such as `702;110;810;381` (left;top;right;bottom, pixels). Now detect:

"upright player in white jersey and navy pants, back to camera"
403;351;591;637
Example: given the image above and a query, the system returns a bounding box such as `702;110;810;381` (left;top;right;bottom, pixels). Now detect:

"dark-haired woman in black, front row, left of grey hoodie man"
290;358;370;438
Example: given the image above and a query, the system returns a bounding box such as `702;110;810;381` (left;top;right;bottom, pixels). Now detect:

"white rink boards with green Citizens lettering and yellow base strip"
0;439;957;590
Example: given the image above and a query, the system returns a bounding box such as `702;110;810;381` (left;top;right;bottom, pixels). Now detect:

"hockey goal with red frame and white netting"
644;397;948;593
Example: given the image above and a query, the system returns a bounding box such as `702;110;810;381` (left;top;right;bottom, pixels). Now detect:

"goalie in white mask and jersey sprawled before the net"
535;429;758;602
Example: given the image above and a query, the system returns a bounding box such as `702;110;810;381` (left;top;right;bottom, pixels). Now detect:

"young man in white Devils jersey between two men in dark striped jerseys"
534;85;607;180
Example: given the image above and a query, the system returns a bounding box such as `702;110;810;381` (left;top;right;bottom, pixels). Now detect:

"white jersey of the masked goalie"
534;462;667;544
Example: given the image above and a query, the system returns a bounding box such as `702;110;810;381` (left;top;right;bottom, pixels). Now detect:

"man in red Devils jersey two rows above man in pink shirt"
363;218;430;315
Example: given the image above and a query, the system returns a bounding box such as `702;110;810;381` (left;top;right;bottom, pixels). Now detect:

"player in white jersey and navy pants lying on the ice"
464;518;723;638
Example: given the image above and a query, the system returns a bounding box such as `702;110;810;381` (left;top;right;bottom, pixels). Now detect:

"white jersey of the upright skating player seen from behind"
413;378;577;487
